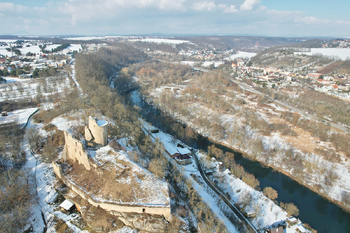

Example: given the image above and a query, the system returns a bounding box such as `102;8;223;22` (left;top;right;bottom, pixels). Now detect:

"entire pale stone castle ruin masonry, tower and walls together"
52;117;171;223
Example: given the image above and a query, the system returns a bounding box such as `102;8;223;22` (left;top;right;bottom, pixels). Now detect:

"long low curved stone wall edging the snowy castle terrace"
52;162;171;220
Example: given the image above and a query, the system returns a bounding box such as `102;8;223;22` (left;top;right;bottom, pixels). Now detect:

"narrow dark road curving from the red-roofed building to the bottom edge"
191;150;258;233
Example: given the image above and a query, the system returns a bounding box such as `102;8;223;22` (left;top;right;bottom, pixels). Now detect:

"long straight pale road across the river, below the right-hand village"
231;79;350;133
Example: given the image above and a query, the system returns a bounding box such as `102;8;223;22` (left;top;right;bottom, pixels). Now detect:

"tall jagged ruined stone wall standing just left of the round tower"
62;131;91;170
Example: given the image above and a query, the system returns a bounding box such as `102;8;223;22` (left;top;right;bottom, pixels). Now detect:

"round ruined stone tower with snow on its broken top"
85;116;108;146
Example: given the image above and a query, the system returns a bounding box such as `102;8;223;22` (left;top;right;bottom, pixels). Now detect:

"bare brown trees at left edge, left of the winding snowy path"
0;123;35;232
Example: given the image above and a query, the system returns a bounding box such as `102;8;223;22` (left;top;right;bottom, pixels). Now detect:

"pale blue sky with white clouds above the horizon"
0;0;350;37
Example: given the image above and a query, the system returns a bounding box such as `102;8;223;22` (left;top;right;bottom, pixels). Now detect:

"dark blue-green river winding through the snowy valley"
129;91;350;233
